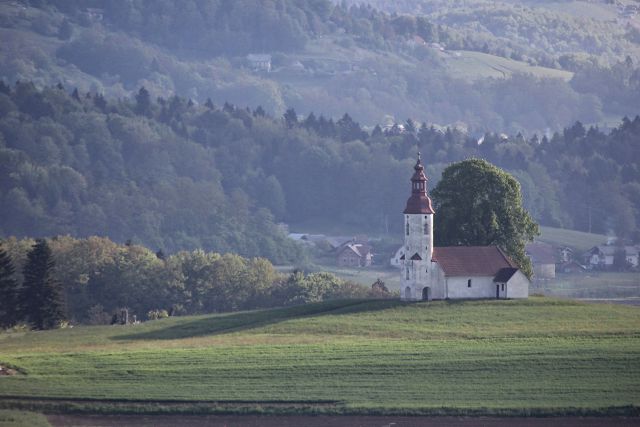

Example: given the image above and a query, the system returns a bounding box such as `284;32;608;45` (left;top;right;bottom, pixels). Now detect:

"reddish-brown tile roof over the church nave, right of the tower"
433;246;517;276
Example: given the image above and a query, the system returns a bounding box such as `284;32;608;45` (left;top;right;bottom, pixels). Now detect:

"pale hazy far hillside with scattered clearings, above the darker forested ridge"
0;0;640;135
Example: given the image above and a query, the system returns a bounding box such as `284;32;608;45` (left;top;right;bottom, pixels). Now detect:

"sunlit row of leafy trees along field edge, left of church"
0;236;387;322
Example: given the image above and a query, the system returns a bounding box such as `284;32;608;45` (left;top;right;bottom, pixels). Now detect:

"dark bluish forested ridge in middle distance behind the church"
0;82;640;258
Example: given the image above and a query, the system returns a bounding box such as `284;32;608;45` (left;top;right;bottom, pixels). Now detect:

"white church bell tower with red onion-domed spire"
400;153;434;301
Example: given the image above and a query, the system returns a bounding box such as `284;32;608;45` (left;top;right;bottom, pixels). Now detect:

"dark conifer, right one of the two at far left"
20;239;65;329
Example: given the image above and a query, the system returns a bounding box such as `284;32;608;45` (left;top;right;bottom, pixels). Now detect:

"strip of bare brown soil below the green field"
47;415;640;427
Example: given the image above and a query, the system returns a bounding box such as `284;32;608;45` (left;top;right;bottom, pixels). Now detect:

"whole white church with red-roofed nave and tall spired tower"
399;153;529;301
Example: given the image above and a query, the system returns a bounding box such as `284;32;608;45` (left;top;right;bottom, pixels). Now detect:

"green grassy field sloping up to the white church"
0;298;640;415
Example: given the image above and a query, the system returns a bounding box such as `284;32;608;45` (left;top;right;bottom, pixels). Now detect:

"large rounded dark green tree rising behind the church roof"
431;159;539;277
